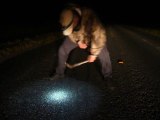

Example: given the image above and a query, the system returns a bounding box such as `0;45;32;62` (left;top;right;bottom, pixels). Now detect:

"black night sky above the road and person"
1;0;160;42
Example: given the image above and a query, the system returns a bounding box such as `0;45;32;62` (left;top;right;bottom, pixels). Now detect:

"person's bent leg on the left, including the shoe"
50;37;77;79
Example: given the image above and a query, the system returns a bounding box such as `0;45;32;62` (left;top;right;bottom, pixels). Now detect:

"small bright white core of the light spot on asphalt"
46;90;72;103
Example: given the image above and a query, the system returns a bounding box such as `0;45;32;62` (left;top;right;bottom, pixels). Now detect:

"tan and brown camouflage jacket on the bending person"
69;8;107;56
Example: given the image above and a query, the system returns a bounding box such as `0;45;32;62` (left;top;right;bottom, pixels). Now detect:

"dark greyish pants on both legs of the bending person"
56;38;112;77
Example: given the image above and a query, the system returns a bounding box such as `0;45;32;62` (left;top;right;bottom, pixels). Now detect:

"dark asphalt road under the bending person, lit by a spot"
0;26;160;120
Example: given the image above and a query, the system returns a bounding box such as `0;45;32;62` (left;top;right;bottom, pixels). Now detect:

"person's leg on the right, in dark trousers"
98;46;112;79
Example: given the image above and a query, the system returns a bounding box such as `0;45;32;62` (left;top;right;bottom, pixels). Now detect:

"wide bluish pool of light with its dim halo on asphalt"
4;78;103;120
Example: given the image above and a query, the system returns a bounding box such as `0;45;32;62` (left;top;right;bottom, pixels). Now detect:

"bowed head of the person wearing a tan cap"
59;7;81;36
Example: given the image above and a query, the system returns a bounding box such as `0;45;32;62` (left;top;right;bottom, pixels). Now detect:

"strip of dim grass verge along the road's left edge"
0;33;61;63
